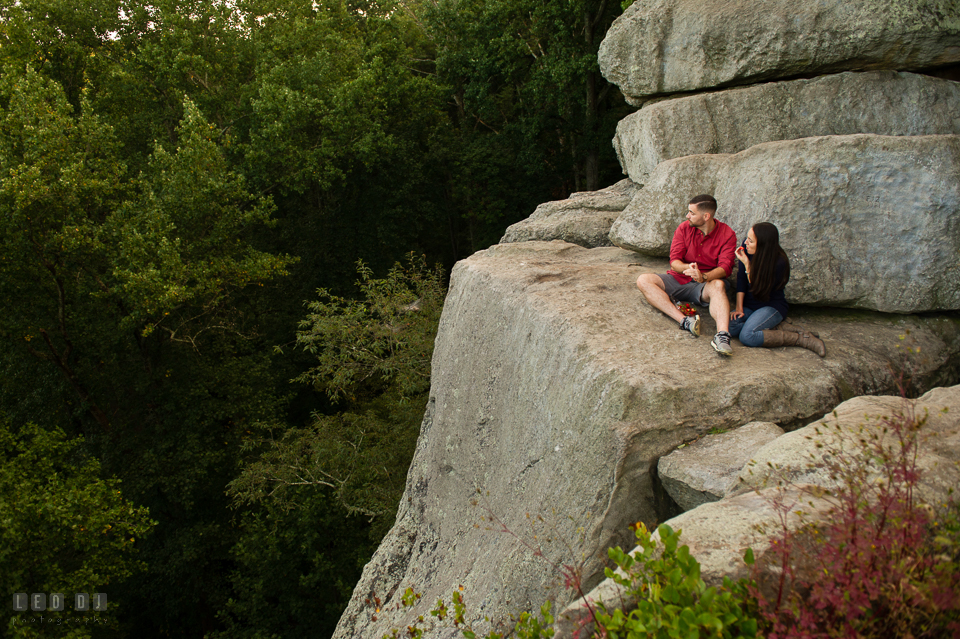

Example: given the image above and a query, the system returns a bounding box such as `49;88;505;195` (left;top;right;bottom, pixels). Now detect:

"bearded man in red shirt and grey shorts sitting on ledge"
637;195;737;357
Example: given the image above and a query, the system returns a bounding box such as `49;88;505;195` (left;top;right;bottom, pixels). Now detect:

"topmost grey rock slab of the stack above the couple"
599;0;960;104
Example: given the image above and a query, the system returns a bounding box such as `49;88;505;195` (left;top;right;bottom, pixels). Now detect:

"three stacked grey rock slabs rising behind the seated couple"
504;0;960;313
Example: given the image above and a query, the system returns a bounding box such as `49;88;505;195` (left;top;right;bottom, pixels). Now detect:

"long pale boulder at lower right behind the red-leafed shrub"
556;386;960;639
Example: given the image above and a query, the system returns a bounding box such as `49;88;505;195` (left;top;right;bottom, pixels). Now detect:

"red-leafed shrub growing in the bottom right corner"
754;400;960;639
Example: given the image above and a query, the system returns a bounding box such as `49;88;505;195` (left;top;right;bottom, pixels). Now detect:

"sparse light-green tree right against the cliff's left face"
231;255;444;536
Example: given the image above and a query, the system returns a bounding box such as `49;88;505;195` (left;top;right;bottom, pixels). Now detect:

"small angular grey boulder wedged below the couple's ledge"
657;422;783;510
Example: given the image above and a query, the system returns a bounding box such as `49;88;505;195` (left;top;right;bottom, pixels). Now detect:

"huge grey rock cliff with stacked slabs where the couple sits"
335;0;960;639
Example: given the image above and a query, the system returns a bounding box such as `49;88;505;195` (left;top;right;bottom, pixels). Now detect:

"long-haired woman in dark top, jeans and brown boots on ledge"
730;222;827;357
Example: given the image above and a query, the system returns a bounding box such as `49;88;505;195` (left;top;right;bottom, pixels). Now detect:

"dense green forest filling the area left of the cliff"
0;0;624;637
